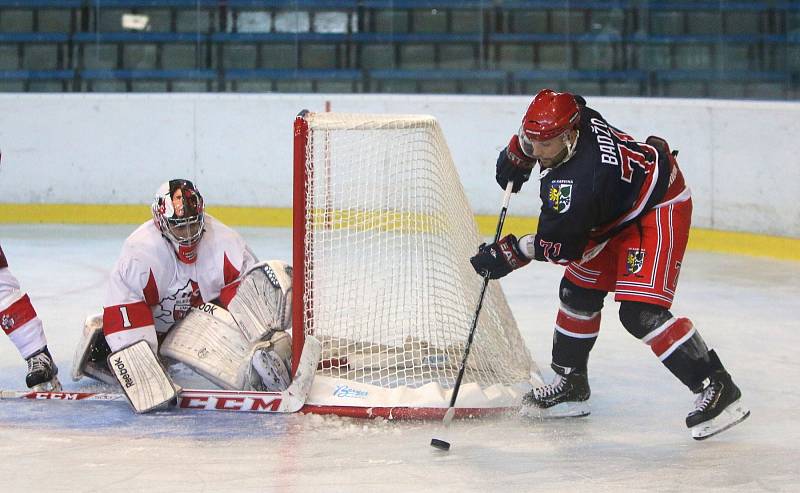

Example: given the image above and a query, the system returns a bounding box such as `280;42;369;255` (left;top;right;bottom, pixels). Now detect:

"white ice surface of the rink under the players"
0;225;800;492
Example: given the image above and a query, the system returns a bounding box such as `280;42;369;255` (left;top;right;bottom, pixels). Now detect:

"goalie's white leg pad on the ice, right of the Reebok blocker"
159;307;251;390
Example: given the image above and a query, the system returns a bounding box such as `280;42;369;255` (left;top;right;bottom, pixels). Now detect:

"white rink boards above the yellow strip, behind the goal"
0;94;800;237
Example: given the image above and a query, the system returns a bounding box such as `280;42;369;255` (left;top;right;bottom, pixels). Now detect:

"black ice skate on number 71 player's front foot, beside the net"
520;364;591;418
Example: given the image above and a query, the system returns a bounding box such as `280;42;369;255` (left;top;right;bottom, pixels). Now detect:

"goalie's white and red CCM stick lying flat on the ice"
0;336;322;413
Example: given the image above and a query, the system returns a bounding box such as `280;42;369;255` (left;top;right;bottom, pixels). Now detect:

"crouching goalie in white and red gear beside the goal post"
72;179;291;412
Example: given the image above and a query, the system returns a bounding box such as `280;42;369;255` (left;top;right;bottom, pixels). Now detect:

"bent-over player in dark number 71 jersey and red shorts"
471;89;750;439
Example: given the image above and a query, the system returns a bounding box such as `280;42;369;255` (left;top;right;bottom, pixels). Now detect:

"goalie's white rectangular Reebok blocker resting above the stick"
108;340;178;413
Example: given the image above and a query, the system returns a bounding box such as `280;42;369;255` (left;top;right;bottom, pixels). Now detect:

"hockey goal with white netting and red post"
293;112;538;418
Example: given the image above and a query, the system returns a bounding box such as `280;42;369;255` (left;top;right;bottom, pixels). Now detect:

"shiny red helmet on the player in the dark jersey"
520;89;581;142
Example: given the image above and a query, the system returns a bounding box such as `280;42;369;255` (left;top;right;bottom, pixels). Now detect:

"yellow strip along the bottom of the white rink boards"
0;204;800;261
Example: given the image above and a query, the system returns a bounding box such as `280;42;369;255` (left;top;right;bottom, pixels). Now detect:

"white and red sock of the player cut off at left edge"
0;243;47;358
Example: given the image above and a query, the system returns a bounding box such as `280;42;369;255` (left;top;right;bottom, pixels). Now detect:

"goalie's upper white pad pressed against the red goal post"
228;260;292;343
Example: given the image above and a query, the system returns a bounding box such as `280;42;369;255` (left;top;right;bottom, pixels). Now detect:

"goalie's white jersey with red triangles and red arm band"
103;214;257;351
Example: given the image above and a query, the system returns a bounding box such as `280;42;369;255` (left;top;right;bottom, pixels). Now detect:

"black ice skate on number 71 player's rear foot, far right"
686;351;750;440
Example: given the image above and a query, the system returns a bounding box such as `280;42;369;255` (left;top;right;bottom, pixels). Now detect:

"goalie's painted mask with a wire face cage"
152;179;204;264
